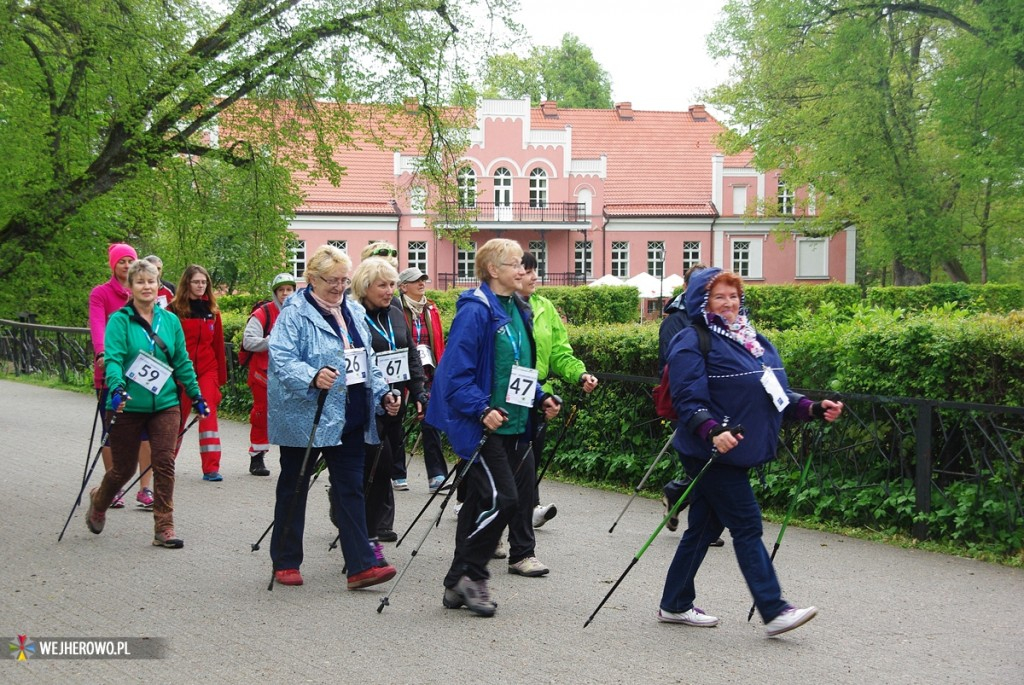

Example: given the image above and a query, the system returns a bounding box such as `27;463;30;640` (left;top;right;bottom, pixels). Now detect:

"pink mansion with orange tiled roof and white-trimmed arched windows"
276;99;856;289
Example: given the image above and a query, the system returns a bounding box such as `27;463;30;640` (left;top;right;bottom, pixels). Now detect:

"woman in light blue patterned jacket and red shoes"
267;246;399;590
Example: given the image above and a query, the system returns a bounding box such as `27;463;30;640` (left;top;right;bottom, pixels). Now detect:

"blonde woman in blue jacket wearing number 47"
426;239;559;616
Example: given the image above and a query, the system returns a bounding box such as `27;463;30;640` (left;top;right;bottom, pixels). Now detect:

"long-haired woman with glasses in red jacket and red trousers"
168;264;227;480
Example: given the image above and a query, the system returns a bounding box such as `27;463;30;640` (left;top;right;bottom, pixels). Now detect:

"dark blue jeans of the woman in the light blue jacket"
270;430;377;575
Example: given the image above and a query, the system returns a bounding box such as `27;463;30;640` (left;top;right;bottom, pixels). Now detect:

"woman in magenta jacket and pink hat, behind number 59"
89;243;153;509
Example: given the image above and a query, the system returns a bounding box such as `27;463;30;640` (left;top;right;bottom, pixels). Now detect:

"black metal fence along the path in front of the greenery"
0;319;1024;551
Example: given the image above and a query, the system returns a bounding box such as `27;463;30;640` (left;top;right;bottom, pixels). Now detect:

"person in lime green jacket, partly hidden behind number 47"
508;252;597;577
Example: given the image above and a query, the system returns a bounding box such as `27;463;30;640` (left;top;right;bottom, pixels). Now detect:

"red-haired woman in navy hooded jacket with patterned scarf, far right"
657;268;843;637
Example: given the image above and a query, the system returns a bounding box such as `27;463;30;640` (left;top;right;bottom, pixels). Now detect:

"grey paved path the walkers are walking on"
0;381;1024;685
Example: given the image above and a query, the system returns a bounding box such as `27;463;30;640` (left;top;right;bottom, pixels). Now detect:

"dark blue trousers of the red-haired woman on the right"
660;457;787;623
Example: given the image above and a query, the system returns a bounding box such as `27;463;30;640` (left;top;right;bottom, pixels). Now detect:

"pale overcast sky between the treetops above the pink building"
509;0;728;111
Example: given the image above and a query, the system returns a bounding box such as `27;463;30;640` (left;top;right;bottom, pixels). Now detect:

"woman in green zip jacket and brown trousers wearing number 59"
85;260;210;549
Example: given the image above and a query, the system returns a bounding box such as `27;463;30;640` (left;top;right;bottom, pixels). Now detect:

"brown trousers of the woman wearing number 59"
93;406;180;532
